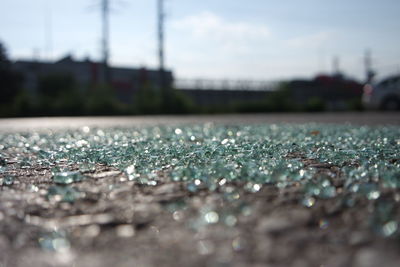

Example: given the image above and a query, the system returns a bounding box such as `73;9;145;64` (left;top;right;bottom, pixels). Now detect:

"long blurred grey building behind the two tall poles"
13;55;173;103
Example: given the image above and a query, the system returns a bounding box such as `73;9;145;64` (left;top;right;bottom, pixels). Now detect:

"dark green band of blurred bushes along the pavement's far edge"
0;39;362;117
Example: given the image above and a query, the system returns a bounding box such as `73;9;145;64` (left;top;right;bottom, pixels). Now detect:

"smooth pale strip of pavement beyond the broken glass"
0;112;400;132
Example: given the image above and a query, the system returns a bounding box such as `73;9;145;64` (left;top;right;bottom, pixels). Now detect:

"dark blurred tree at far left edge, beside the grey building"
0;42;22;104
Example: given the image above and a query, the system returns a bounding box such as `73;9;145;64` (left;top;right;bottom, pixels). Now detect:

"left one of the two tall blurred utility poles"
101;0;110;84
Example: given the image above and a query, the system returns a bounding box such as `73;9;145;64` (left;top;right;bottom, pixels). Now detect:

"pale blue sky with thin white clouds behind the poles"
0;0;400;80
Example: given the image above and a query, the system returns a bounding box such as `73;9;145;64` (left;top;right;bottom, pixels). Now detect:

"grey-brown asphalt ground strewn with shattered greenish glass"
0;112;400;267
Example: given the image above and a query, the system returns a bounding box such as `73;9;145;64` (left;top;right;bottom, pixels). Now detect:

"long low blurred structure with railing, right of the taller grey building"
174;75;363;110
